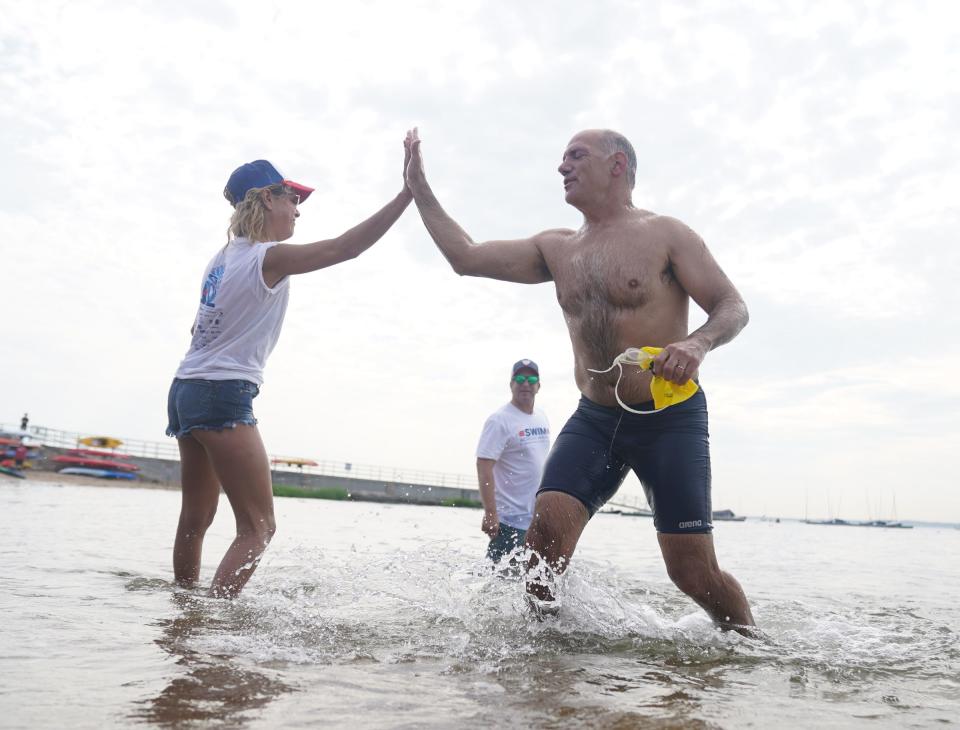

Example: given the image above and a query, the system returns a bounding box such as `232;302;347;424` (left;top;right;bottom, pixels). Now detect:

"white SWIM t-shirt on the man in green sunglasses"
477;403;550;530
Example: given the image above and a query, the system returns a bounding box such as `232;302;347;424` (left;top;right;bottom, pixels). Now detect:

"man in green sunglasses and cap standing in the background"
477;360;550;562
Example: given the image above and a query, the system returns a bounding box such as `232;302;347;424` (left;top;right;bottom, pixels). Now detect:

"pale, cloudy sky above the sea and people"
0;0;960;522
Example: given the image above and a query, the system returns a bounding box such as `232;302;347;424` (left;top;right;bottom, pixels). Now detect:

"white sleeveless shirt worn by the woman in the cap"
176;238;290;385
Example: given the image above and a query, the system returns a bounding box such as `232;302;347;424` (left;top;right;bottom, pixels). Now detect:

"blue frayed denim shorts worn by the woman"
167;378;260;438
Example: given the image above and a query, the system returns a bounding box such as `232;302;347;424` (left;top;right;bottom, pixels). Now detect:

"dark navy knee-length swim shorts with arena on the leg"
537;388;713;533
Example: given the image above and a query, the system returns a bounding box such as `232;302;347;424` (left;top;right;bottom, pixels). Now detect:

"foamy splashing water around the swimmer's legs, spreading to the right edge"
127;541;957;707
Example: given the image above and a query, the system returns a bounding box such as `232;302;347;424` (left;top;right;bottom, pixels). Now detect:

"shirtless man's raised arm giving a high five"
406;129;566;284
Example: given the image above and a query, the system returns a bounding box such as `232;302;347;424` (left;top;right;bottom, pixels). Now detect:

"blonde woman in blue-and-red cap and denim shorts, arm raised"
167;134;412;598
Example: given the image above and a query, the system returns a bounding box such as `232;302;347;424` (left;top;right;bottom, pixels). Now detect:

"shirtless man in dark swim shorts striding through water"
407;130;754;632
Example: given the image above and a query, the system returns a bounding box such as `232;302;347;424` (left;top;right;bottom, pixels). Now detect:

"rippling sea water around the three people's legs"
0;481;960;728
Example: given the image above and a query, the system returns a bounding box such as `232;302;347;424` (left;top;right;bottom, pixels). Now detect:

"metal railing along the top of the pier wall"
0;423;477;489
